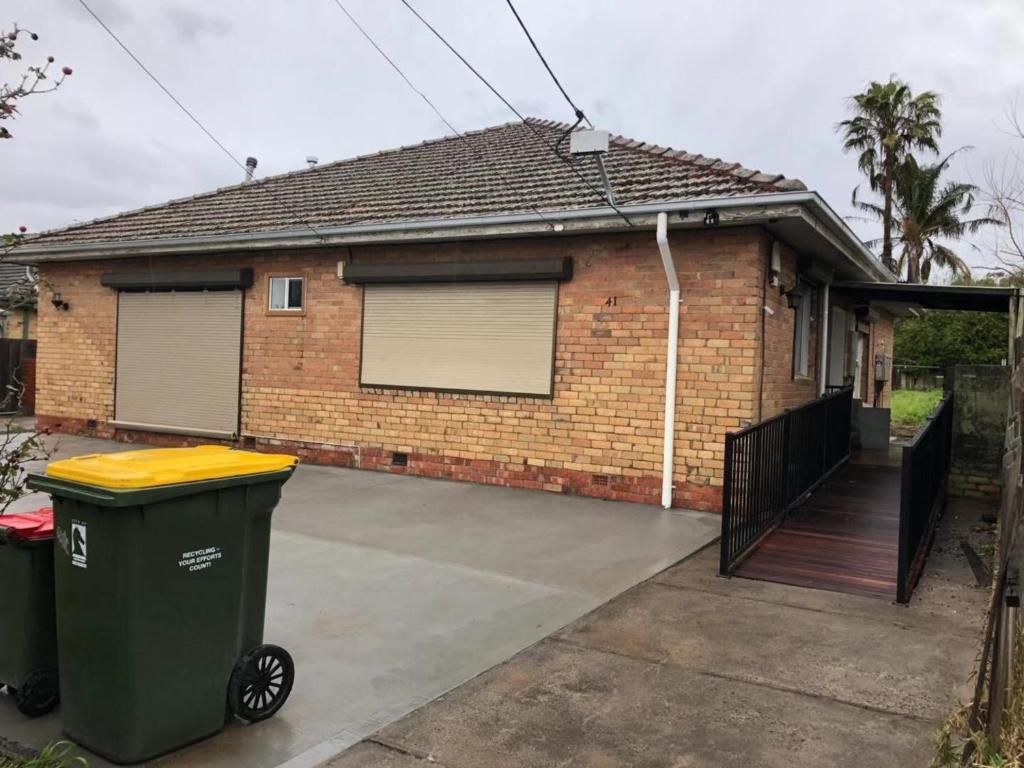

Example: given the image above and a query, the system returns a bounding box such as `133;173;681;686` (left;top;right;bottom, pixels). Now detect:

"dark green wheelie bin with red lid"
0;508;59;717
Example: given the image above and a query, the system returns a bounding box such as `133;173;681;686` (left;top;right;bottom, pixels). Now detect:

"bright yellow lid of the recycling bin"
46;445;299;488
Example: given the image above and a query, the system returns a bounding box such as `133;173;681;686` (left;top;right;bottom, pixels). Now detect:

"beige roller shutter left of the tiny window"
115;291;242;437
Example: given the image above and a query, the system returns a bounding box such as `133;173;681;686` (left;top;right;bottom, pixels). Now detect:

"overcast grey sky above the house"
0;0;1024;272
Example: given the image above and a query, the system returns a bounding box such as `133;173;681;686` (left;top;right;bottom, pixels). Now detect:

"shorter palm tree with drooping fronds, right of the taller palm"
853;150;1000;283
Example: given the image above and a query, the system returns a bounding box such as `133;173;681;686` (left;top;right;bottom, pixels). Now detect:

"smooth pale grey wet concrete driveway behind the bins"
0;437;719;768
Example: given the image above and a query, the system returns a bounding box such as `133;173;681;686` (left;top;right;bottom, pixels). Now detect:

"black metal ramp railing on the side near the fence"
896;394;953;603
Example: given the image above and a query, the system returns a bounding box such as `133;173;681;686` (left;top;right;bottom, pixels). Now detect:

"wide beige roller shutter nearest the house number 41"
360;281;558;395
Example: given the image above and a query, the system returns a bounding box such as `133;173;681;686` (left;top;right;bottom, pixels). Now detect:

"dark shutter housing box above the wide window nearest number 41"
342;256;572;285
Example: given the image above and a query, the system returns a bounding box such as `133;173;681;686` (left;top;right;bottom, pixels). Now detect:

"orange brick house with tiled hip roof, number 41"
17;120;894;510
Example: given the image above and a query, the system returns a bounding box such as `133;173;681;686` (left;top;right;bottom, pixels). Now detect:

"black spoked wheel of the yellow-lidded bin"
227;645;295;723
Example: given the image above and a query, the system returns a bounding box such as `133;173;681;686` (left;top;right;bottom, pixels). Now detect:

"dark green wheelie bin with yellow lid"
29;445;297;763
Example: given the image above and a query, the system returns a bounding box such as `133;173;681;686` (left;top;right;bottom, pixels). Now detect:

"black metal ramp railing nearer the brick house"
719;387;853;575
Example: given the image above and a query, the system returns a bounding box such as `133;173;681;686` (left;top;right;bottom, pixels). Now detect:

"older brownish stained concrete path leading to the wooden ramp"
329;495;988;768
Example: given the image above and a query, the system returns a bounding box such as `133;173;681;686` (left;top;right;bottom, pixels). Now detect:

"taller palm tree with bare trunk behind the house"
836;76;942;271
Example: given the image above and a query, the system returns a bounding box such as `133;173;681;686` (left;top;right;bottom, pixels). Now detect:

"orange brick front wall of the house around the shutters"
37;228;798;518
